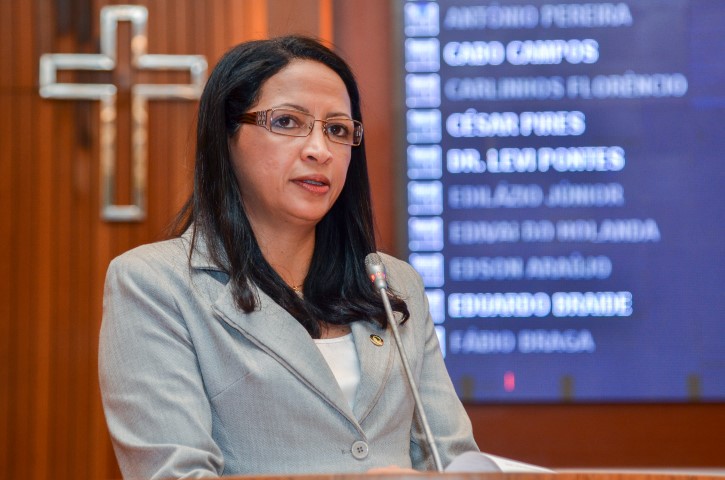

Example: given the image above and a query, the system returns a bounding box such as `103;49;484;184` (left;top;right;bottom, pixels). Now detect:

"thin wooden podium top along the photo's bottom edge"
225;470;725;480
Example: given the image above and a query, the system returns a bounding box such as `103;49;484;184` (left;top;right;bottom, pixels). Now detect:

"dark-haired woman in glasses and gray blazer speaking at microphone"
100;37;477;477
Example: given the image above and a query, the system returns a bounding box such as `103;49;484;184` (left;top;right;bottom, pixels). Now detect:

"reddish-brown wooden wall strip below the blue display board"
468;404;725;468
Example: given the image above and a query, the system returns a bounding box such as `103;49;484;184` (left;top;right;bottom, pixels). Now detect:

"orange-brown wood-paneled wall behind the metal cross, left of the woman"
0;0;332;479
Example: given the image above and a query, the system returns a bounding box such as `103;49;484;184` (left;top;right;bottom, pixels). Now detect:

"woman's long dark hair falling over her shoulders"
171;36;409;338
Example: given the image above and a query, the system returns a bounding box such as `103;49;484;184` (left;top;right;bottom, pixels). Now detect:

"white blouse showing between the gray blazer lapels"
315;333;360;409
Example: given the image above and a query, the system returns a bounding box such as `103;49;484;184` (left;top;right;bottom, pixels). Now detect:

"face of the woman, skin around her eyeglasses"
229;60;352;232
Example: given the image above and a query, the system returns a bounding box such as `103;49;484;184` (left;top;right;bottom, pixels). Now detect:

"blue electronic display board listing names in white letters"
401;0;725;402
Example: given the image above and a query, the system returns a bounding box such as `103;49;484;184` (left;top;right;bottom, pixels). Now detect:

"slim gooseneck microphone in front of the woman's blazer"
365;253;443;473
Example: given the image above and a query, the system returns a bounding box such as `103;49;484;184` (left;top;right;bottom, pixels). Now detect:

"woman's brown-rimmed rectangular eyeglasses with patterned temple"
239;108;362;147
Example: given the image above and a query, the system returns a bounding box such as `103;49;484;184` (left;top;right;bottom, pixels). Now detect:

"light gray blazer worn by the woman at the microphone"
99;232;478;478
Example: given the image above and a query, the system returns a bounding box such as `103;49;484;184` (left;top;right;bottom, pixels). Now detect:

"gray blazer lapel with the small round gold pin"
352;321;396;423
